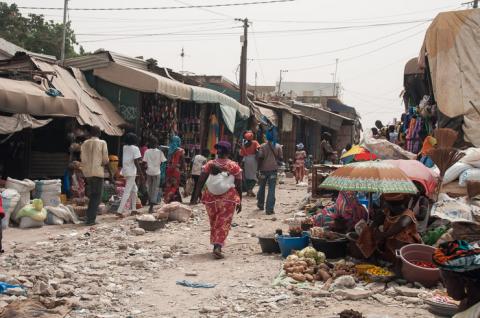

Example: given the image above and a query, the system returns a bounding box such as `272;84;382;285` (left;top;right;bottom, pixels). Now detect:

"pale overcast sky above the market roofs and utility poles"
6;0;465;127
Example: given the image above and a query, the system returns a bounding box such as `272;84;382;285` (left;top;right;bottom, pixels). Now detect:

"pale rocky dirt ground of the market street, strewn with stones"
0;180;440;318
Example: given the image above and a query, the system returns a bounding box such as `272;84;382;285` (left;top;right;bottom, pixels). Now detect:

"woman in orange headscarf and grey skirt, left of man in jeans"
240;131;260;198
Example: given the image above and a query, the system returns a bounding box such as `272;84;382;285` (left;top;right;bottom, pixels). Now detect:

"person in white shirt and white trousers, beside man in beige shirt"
118;133;144;216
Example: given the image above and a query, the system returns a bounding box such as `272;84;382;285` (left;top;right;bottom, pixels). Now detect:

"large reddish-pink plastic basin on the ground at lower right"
397;244;440;287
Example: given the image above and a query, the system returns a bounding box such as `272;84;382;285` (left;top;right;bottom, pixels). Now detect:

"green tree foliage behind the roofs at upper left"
0;2;78;58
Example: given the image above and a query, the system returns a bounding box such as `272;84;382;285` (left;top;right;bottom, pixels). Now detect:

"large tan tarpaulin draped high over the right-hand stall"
419;9;480;147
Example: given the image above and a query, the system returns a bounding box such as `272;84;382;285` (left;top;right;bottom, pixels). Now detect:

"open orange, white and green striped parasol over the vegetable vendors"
320;160;417;194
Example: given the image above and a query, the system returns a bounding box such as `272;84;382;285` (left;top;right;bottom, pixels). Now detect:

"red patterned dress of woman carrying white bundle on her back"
202;159;242;246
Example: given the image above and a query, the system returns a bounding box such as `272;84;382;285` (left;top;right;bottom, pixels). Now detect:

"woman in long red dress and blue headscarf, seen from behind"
163;136;185;204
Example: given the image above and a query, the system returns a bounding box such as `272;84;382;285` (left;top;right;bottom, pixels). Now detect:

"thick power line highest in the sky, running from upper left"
18;0;295;11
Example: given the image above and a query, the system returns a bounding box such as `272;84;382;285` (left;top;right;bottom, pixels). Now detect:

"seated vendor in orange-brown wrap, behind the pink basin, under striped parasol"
357;194;422;263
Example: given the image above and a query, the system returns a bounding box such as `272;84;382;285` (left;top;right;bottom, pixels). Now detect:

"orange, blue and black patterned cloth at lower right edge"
433;240;480;272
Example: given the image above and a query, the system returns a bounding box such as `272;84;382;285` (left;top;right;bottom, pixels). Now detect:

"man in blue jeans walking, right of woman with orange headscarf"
257;130;283;215
